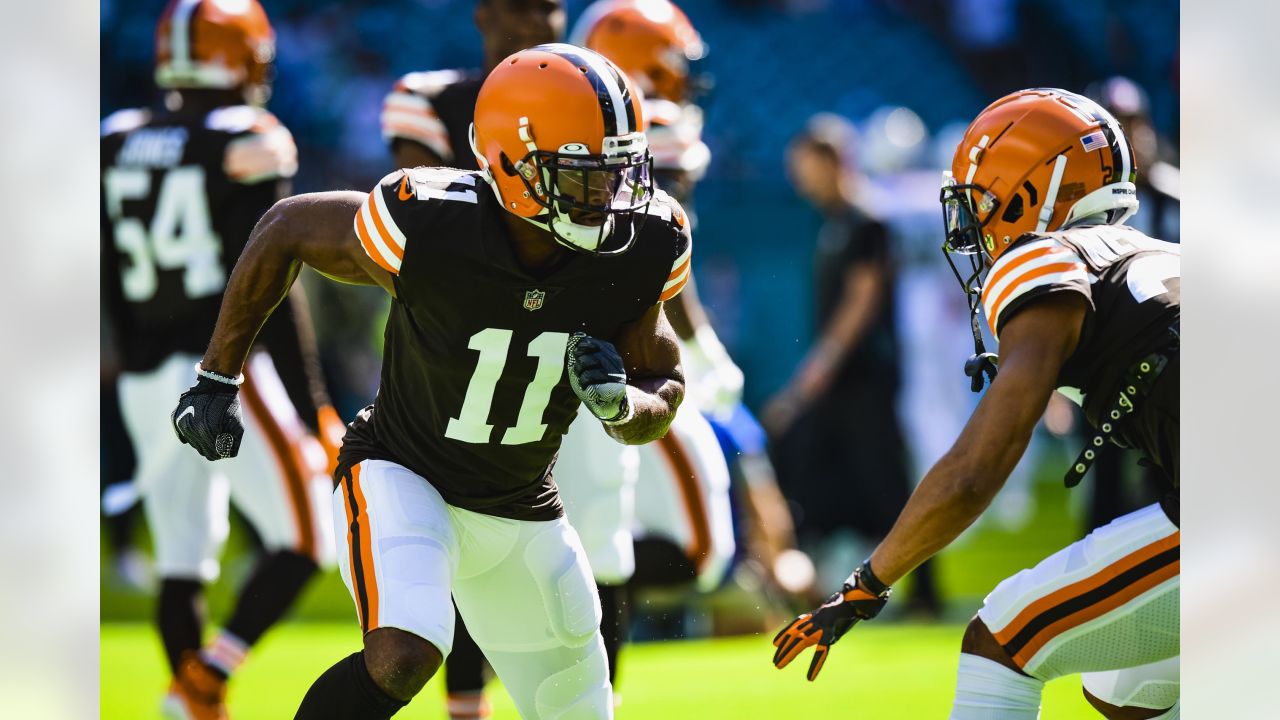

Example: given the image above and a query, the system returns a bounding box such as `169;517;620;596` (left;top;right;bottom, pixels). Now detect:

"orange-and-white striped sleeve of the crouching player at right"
982;237;1093;338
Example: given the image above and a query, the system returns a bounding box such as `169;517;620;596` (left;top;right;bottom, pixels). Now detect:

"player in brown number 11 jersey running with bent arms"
173;44;692;720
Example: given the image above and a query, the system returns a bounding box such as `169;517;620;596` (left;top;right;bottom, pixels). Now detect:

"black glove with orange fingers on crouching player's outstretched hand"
773;561;892;682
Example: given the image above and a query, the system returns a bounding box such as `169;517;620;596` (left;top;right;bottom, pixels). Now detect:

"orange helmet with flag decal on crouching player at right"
940;88;1138;392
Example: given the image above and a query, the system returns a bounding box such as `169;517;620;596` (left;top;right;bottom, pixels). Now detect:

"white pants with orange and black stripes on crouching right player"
978;505;1180;707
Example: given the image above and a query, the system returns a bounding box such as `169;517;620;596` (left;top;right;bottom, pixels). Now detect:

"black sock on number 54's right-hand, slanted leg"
225;550;316;646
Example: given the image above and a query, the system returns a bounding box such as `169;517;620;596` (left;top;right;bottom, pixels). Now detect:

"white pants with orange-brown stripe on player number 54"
119;352;333;582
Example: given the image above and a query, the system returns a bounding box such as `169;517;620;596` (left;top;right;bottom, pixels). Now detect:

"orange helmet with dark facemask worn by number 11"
471;42;653;255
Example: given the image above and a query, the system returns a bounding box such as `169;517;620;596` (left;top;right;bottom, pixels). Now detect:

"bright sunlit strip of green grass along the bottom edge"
101;621;1097;720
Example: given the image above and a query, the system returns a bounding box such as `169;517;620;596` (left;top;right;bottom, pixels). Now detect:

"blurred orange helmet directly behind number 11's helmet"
570;0;707;102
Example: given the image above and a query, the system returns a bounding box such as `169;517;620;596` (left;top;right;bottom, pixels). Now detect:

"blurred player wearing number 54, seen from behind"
101;0;340;719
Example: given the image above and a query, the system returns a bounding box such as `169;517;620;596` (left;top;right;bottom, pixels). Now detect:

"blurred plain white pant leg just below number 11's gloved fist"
556;405;640;585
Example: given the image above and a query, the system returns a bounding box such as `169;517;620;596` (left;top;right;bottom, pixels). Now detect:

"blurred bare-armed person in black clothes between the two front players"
764;113;941;615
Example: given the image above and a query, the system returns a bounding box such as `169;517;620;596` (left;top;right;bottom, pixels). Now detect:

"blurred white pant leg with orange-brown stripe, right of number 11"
635;405;735;591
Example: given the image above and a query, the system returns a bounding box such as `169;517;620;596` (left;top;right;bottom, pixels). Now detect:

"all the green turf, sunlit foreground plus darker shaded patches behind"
101;440;1098;720
